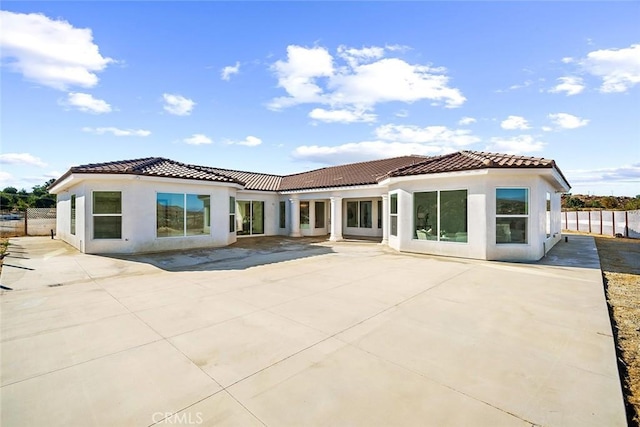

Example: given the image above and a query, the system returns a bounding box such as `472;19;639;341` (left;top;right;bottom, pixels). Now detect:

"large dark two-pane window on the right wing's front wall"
413;190;468;243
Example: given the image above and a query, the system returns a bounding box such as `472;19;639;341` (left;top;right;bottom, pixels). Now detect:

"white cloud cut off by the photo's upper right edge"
581;44;640;93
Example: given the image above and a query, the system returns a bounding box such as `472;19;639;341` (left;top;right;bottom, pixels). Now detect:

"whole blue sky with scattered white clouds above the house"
0;1;640;196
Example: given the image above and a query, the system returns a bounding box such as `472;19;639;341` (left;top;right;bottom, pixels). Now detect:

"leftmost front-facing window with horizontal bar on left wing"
92;191;122;239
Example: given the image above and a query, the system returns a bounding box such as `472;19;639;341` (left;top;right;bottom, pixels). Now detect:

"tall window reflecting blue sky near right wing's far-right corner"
496;188;529;243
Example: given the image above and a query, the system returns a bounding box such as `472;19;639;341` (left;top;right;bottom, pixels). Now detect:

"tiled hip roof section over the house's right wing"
386;151;568;184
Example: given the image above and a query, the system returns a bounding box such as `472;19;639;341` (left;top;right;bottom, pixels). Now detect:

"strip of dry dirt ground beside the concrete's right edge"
595;236;640;426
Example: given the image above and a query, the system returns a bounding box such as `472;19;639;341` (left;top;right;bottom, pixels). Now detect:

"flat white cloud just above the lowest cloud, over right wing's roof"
375;124;480;146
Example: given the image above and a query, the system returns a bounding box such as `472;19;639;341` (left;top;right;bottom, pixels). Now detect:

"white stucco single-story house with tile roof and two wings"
49;151;570;260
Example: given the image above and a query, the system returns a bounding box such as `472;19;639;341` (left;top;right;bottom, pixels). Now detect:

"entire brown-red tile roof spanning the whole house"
51;151;569;191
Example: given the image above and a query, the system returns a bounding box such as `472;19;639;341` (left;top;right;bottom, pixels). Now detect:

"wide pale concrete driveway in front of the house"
0;236;626;427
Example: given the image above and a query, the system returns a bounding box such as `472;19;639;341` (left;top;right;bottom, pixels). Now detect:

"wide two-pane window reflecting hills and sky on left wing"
156;193;211;237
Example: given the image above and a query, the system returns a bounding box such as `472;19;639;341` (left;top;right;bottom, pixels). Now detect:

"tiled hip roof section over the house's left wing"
51;157;244;187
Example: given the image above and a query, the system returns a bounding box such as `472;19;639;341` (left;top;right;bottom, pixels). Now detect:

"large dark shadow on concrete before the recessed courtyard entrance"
102;236;334;271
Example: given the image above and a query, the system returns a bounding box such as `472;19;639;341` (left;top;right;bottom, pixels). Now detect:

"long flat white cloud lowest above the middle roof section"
291;141;444;165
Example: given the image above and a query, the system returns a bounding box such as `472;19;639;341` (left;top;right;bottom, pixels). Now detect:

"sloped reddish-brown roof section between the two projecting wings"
280;156;427;191
